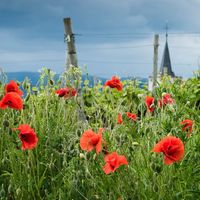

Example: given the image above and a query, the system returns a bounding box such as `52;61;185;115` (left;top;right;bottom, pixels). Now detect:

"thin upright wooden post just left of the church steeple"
153;34;159;88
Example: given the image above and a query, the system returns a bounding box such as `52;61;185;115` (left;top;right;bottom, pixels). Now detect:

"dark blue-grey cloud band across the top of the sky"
0;0;200;32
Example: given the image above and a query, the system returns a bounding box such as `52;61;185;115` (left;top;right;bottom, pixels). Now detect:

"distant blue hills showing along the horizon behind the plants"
2;72;148;85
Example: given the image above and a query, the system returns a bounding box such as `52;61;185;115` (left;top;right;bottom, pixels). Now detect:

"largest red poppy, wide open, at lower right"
152;136;184;165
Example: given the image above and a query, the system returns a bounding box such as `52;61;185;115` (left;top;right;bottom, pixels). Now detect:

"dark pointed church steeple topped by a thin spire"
160;25;175;77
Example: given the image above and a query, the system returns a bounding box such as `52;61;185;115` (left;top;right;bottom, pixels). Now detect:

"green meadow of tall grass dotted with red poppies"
0;68;200;200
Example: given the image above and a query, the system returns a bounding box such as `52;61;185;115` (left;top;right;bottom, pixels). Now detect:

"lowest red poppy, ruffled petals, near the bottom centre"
103;152;128;174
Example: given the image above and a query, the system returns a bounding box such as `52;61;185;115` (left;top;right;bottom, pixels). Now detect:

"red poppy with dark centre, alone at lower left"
14;124;38;150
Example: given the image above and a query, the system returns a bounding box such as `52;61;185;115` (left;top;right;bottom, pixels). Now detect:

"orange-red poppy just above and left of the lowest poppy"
80;128;103;154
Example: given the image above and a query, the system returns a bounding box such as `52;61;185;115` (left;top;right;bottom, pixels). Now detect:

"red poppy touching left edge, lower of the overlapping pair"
0;92;23;110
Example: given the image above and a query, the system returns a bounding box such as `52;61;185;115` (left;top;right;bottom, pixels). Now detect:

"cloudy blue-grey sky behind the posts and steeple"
0;0;200;78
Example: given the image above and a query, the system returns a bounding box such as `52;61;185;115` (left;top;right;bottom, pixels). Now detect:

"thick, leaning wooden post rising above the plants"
64;17;78;69
